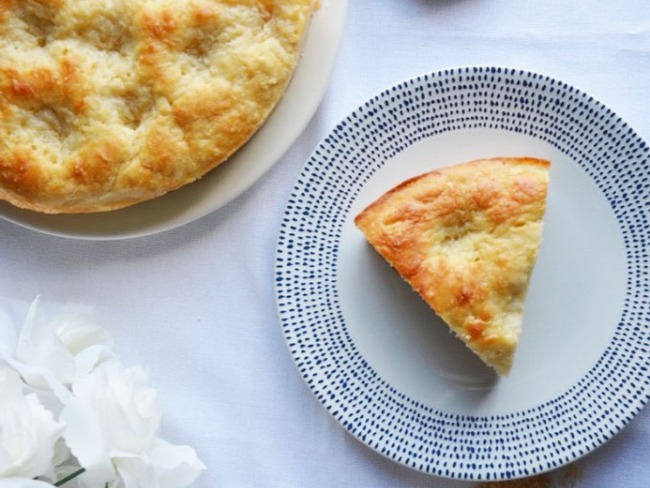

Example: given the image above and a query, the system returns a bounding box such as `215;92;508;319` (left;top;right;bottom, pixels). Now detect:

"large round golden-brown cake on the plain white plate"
0;0;312;213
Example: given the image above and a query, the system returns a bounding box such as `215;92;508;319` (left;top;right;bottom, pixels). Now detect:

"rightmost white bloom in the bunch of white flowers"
61;359;204;488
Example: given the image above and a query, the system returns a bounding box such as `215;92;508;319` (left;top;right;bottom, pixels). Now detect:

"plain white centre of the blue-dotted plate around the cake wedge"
338;129;626;415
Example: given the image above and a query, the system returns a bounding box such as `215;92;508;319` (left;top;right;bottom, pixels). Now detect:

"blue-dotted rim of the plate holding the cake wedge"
275;67;650;480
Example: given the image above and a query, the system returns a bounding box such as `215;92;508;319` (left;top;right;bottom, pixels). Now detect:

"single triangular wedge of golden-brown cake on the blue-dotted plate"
355;157;550;375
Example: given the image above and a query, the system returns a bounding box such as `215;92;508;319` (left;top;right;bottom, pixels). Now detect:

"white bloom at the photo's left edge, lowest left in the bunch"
0;367;61;478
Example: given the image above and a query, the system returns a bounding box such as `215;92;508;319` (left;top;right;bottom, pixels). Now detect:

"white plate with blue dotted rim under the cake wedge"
276;67;650;480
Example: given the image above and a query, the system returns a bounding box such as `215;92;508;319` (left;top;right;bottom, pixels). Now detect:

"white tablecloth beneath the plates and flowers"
0;0;650;488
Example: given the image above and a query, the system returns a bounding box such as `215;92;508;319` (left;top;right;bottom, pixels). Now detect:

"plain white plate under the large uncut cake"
0;0;347;240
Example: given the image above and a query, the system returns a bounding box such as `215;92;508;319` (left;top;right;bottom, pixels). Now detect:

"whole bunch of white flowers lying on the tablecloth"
0;300;205;488
